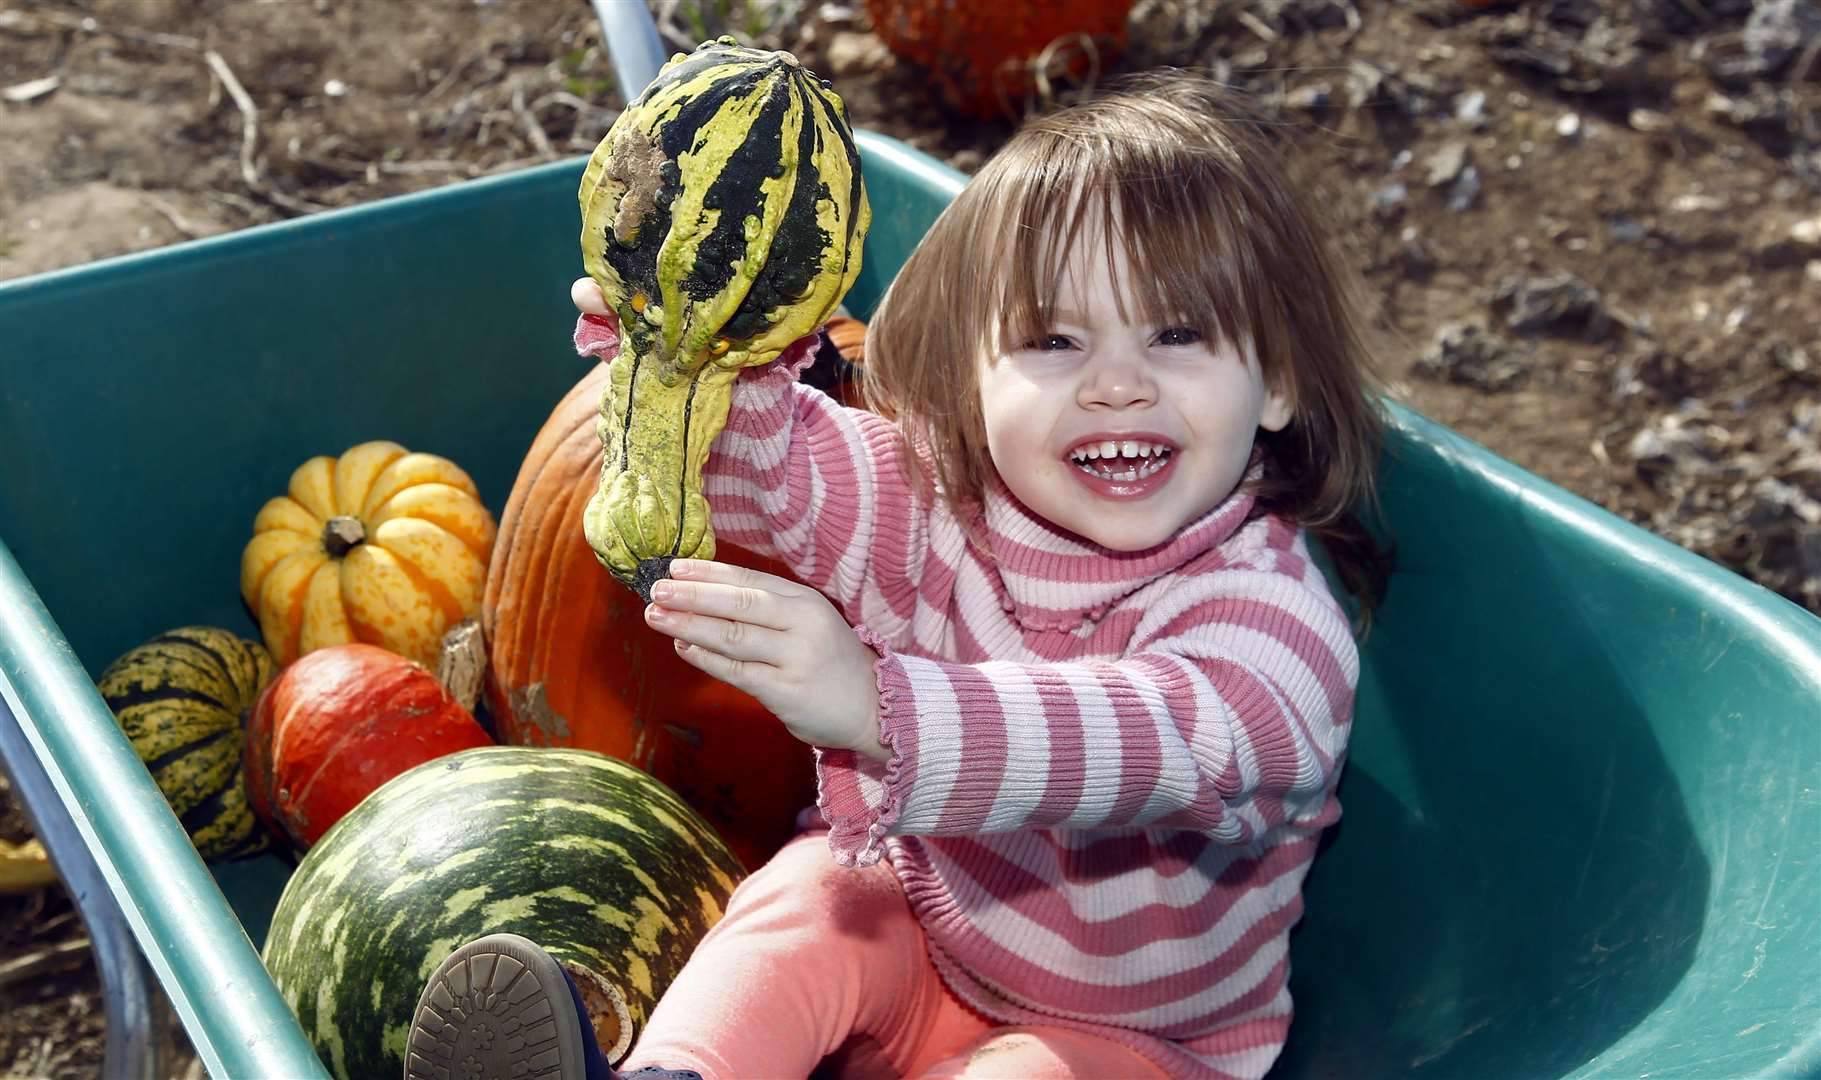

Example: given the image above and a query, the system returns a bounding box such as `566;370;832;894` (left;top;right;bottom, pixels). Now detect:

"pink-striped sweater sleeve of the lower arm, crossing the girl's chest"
816;568;1358;865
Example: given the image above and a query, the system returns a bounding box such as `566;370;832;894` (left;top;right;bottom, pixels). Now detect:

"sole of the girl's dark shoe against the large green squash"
404;934;701;1080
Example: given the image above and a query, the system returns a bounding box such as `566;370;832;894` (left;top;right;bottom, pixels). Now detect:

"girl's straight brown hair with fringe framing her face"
865;71;1388;612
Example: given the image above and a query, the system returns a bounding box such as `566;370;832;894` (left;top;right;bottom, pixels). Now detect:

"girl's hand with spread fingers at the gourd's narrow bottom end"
645;559;890;761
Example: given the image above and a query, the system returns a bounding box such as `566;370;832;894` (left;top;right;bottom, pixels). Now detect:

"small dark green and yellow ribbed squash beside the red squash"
98;627;273;860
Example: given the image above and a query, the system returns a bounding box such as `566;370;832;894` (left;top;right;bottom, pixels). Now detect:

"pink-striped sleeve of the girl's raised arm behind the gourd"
575;315;929;614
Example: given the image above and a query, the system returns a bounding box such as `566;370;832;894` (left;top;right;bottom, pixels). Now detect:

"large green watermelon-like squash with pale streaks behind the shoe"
264;747;743;1078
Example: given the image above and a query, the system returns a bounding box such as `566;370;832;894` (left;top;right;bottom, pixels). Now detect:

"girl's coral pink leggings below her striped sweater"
619;832;1162;1080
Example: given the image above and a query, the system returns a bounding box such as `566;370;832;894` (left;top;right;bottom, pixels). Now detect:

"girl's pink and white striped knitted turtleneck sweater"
577;320;1358;1078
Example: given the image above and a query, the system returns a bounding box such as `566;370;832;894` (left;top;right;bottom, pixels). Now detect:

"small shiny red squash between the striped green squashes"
246;645;493;851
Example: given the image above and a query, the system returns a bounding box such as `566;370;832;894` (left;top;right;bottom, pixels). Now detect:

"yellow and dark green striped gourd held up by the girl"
579;36;872;596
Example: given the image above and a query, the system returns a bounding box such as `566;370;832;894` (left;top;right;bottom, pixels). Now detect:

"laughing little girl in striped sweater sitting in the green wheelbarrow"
410;75;1382;1080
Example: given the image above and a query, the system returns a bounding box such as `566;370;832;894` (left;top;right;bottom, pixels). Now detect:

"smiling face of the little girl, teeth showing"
978;228;1291;552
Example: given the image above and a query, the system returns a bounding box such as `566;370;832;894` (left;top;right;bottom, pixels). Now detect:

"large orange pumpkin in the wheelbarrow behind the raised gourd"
481;364;816;867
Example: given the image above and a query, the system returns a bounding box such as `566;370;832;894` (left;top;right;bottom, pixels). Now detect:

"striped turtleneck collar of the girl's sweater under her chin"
983;464;1260;630
